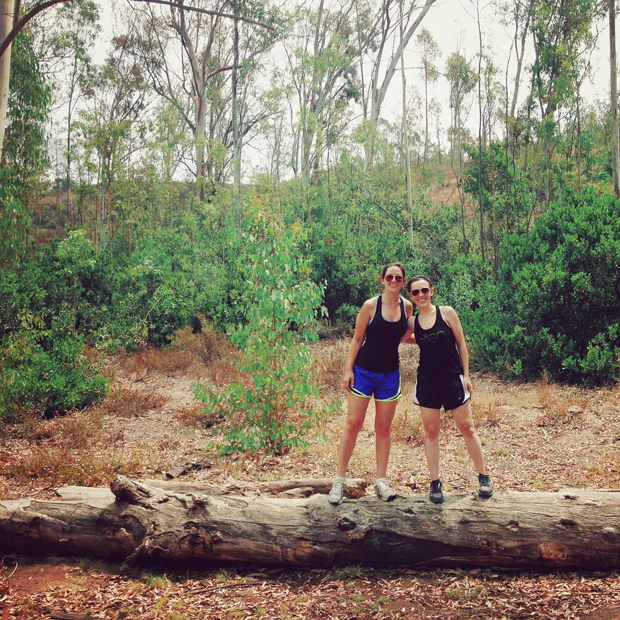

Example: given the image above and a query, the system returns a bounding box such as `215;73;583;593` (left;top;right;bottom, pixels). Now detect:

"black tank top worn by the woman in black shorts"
413;306;463;380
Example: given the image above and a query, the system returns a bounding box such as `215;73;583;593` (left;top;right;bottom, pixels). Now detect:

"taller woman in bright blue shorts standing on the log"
329;263;413;505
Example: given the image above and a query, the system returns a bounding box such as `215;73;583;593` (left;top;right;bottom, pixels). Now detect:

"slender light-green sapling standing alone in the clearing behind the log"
196;215;336;454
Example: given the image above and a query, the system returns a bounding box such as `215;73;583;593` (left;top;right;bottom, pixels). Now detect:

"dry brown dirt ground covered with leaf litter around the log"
0;340;620;620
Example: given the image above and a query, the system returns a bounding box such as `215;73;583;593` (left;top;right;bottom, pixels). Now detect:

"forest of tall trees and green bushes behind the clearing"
0;0;620;426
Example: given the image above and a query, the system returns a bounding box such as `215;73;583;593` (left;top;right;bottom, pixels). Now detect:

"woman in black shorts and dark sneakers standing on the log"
403;276;493;504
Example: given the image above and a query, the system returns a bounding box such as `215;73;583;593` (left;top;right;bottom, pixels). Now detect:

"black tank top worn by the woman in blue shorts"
355;295;407;373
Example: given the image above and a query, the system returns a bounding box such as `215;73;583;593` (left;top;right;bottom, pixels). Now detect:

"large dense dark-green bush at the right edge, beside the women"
471;189;620;385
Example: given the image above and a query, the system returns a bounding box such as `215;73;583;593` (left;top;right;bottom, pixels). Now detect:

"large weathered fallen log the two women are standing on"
0;476;620;570
